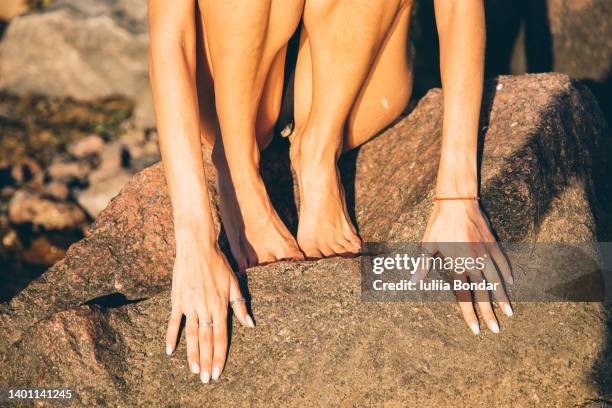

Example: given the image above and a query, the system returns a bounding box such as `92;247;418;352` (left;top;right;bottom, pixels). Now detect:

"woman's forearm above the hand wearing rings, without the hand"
150;3;216;242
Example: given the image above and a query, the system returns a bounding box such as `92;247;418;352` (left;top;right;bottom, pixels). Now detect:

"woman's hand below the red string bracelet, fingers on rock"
413;200;513;334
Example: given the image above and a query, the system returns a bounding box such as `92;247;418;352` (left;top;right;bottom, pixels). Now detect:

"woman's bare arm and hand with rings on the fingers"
149;0;253;383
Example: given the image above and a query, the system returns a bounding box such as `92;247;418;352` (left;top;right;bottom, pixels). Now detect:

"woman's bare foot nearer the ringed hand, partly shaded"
213;145;304;269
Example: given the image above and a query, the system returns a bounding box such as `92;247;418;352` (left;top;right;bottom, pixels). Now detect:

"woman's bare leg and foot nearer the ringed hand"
200;0;303;268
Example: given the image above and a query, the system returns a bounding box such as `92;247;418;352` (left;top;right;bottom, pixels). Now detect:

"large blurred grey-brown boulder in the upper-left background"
0;0;153;126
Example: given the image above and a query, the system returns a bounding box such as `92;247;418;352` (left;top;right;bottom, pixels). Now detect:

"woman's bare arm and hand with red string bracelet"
415;0;512;334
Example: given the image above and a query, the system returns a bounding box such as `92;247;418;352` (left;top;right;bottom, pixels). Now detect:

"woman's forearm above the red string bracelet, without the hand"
435;0;485;197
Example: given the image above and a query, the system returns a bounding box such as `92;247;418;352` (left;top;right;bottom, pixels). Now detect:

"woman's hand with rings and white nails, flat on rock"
166;232;255;383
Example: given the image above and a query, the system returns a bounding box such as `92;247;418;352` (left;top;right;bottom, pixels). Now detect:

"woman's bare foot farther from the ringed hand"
290;125;361;259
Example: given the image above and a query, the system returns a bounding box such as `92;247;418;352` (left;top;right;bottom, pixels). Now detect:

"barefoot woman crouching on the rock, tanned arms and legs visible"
149;0;511;382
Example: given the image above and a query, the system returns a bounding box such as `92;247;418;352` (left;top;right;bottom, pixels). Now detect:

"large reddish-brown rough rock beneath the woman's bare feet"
0;74;612;407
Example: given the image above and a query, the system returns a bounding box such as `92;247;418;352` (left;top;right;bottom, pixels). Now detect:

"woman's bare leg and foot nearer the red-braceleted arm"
291;0;412;258
